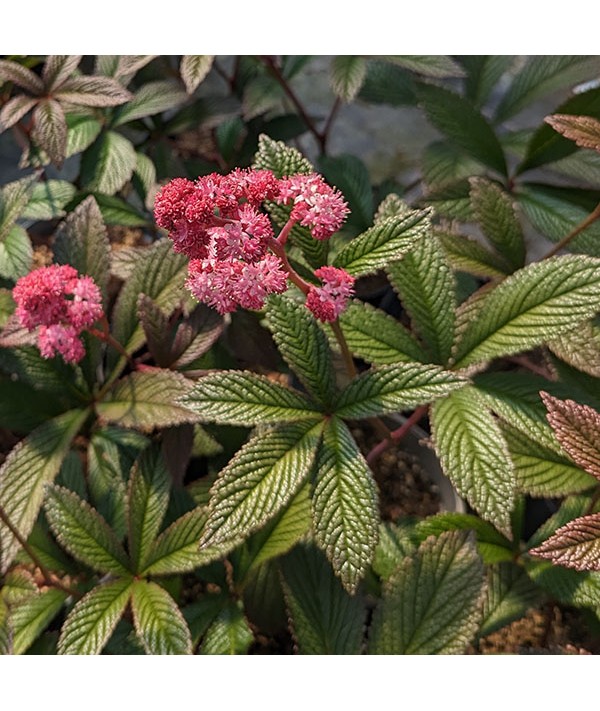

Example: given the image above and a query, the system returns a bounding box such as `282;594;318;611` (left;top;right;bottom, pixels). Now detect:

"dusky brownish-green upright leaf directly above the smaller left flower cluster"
53;195;110;303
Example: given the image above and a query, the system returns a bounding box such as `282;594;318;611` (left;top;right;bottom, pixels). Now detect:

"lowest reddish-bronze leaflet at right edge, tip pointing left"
529;513;600;570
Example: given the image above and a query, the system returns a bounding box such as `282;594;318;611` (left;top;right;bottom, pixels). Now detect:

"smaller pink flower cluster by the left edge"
13;264;104;363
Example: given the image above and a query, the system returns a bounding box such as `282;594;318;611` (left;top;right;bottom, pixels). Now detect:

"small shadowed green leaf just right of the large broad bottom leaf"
479;563;540;637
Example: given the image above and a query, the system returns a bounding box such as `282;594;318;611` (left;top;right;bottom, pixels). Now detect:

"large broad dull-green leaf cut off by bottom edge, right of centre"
369;531;484;654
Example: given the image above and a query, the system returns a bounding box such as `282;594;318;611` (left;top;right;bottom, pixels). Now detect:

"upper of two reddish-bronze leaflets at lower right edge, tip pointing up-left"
540;392;600;479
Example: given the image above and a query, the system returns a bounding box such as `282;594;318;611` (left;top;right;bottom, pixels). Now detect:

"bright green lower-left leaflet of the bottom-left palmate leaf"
58;578;132;654
